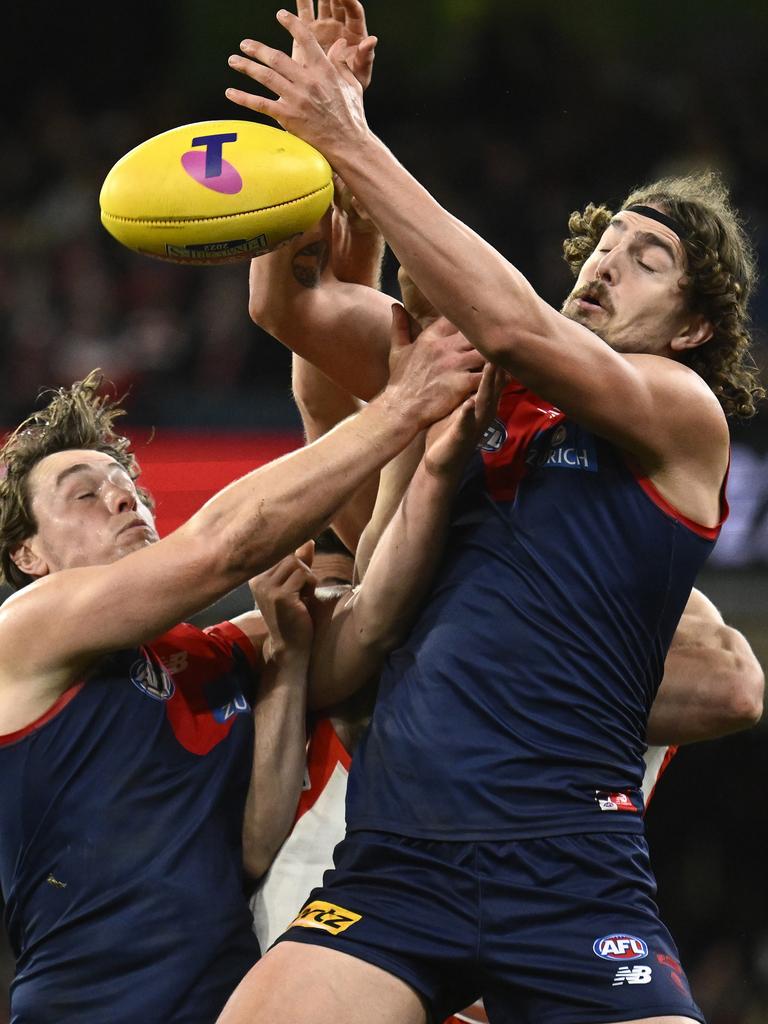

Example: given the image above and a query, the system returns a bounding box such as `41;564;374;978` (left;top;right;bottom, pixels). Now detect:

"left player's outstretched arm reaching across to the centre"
0;315;481;731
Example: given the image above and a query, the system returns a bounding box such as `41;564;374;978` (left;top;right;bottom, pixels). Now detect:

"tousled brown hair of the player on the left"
0;370;152;590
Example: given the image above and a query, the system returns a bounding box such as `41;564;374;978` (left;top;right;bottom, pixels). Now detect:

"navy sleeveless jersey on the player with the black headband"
347;384;725;841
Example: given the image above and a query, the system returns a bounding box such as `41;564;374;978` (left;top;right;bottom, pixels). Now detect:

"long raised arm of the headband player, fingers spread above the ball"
227;11;727;495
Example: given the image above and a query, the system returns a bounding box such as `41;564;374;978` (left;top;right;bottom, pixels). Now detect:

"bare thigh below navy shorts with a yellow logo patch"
217;941;427;1024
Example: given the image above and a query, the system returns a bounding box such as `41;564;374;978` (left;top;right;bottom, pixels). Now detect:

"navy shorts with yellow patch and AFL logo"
279;831;703;1024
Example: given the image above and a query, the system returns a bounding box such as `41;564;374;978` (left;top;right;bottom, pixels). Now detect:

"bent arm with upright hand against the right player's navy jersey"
309;356;507;707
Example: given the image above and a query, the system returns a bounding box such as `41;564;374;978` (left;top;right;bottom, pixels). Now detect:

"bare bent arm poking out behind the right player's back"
647;590;765;745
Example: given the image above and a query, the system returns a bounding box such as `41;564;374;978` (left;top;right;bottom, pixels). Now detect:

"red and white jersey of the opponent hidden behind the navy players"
251;718;677;1024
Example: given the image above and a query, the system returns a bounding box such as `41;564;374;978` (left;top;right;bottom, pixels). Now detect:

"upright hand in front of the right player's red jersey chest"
424;362;510;476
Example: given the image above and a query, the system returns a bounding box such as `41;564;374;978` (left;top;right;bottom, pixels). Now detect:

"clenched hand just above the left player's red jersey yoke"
249;541;316;662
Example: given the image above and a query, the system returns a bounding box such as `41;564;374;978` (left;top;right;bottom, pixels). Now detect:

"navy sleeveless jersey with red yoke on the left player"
0;623;259;1024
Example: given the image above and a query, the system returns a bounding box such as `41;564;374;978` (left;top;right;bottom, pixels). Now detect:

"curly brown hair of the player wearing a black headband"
563;171;765;419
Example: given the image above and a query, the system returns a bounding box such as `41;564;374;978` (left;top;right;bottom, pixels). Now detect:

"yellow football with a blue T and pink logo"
99;121;333;264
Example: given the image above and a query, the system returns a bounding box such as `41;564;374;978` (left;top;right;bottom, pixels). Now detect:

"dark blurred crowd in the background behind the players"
0;0;768;1024
